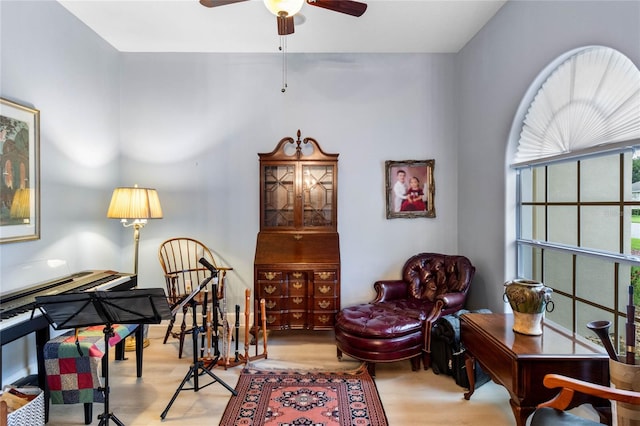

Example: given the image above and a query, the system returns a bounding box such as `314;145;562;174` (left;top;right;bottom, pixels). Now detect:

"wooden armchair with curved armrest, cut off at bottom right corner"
530;374;640;426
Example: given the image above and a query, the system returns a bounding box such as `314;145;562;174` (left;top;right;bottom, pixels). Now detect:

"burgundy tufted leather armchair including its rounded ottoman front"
335;253;475;375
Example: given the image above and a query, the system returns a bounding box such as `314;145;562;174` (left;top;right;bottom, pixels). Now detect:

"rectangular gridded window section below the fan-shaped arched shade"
517;150;640;350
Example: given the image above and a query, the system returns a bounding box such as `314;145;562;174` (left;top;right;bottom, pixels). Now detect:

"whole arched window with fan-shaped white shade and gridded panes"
511;46;640;350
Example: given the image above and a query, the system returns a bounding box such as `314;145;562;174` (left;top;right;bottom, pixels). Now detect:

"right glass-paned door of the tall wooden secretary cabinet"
302;165;334;227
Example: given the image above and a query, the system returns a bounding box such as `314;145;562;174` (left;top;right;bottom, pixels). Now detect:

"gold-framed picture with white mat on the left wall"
0;98;40;243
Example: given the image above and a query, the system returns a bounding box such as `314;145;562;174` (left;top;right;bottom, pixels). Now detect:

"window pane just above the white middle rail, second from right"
580;206;620;253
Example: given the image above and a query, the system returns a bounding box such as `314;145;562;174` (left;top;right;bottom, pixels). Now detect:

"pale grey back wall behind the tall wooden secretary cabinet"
120;54;457;306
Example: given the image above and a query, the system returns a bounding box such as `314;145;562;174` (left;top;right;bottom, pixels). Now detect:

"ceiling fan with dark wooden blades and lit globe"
200;0;367;35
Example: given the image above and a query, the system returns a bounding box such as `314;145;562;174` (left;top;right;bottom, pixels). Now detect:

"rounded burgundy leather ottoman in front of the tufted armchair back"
335;302;424;376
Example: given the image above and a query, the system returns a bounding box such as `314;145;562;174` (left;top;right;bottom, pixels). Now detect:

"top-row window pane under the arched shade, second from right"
580;154;620;202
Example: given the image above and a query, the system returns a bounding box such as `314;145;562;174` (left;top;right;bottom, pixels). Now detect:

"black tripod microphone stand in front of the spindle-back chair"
160;266;238;419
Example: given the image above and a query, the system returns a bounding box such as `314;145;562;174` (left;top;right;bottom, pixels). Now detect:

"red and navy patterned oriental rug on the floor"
220;367;388;426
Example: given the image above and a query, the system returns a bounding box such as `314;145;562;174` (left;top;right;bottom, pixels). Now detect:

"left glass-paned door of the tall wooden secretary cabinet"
262;165;295;227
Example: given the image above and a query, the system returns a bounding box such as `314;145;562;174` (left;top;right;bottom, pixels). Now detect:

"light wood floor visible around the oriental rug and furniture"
48;325;515;426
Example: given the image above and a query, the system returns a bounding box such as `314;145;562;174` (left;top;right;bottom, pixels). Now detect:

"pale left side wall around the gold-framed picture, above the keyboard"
0;1;122;384
